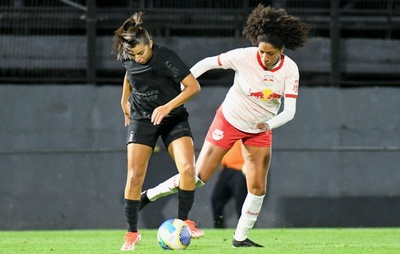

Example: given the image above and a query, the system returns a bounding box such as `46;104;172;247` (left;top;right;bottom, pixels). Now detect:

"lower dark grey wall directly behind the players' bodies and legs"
0;85;400;230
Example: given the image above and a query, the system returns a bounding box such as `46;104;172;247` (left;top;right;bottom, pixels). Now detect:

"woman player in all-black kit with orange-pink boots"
113;12;204;251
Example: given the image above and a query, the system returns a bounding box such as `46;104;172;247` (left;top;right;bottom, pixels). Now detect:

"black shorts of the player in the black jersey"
126;117;193;149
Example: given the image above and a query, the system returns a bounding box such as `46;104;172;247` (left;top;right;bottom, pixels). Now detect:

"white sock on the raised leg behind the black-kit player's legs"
146;174;204;201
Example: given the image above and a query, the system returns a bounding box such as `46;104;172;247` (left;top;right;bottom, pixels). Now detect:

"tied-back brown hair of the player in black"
112;12;152;60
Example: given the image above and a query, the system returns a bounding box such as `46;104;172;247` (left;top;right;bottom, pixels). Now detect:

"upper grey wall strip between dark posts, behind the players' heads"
0;35;400;75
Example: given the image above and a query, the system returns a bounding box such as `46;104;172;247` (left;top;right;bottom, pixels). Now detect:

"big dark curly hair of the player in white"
243;4;310;50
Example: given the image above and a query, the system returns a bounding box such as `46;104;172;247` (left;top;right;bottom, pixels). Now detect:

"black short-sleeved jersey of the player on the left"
122;44;190;120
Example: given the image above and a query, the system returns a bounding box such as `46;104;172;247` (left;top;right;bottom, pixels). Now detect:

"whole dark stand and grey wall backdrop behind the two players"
0;0;400;230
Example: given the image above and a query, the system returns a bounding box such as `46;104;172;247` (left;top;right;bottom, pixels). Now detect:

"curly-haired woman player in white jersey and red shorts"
141;5;310;247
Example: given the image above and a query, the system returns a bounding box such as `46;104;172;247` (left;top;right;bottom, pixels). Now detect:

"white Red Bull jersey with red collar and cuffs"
218;47;299;133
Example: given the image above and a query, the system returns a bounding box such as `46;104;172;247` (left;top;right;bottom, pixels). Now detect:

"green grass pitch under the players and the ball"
0;228;400;254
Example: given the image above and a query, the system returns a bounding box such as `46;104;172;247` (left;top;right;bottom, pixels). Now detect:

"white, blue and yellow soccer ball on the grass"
157;219;192;250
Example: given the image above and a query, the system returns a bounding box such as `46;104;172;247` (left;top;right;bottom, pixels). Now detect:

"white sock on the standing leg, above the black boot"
233;192;265;241
